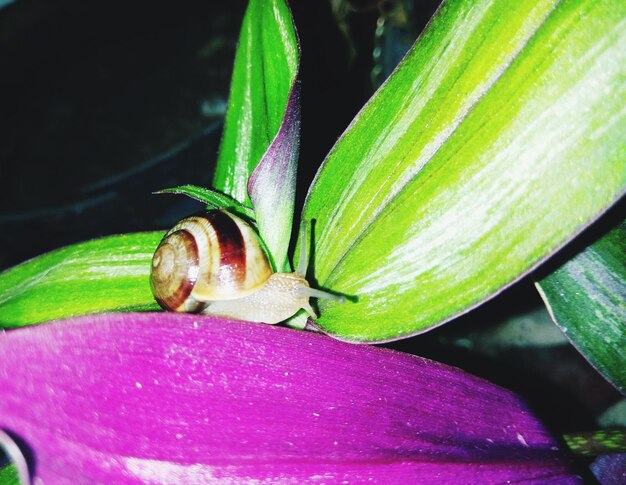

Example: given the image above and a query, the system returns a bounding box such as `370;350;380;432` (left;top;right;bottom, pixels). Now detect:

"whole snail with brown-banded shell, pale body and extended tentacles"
150;209;343;324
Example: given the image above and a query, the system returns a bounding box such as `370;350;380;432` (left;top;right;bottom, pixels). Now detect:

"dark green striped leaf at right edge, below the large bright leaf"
537;222;626;394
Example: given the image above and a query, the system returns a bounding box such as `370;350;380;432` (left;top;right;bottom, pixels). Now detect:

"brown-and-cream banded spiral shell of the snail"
150;210;272;312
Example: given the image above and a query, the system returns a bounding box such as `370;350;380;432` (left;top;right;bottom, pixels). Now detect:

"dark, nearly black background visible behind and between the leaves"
0;0;619;476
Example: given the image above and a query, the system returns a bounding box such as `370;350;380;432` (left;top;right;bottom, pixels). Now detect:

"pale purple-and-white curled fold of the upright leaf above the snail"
248;81;300;271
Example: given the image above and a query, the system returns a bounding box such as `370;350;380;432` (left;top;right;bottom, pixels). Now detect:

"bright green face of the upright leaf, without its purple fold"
213;0;299;206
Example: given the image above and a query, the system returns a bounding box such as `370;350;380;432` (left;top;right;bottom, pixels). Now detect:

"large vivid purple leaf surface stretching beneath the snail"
0;313;577;483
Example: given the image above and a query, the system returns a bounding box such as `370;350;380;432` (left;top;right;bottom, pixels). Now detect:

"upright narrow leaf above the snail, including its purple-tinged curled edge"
213;0;300;269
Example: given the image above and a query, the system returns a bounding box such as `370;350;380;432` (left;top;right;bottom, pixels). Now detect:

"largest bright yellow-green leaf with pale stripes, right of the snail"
303;0;626;341
